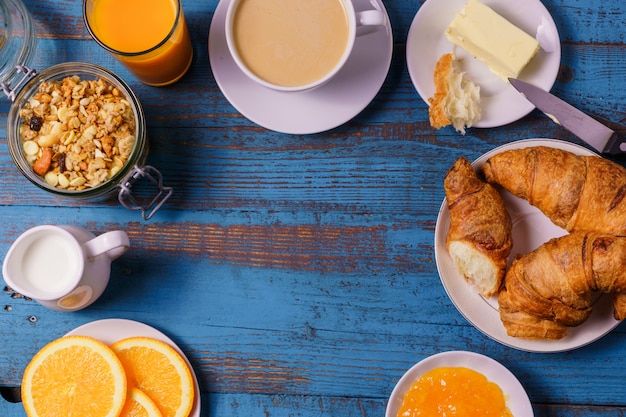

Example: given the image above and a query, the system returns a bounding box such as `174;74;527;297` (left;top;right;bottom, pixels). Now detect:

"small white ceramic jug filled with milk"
2;225;130;311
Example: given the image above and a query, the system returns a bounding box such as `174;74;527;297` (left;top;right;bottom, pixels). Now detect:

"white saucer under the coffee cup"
209;0;393;134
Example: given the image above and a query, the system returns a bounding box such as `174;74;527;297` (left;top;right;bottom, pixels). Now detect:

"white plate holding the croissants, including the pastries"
435;139;626;352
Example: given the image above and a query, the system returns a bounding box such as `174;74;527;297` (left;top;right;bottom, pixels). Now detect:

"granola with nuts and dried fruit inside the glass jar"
19;76;136;190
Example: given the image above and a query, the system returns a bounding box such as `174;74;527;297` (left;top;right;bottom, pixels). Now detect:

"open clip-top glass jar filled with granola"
7;62;172;220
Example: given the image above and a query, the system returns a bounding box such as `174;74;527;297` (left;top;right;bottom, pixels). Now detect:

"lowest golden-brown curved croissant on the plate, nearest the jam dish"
498;231;626;339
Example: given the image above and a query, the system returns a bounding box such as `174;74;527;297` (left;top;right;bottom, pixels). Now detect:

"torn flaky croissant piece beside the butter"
428;53;481;134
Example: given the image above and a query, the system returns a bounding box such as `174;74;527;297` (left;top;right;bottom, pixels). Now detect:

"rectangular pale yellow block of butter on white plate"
446;0;539;82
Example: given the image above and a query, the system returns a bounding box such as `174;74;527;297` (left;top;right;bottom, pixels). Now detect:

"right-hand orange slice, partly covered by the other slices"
111;337;194;417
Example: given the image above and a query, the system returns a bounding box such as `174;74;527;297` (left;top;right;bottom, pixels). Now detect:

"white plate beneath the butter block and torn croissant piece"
406;0;561;128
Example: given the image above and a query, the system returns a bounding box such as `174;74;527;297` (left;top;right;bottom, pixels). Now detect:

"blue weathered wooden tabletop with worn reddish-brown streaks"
0;0;626;417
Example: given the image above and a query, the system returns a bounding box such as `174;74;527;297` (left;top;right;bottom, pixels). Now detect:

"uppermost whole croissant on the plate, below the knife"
483;146;626;235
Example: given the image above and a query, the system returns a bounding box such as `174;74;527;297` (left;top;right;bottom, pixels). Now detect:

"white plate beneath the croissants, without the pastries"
435;139;621;352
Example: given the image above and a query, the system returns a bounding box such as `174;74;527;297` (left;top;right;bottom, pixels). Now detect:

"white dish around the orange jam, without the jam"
385;350;533;417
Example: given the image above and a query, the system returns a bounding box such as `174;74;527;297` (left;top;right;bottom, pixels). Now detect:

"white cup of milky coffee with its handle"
225;0;387;92
